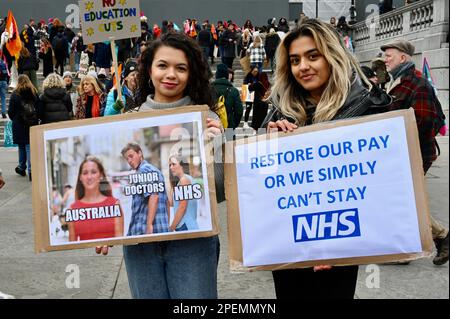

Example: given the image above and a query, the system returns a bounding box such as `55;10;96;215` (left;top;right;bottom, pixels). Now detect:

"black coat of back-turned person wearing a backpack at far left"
8;90;40;144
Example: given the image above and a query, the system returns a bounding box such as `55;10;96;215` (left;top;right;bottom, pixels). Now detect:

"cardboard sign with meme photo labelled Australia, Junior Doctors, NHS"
31;106;218;252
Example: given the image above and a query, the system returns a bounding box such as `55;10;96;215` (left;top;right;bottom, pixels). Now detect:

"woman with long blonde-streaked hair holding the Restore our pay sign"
263;19;391;299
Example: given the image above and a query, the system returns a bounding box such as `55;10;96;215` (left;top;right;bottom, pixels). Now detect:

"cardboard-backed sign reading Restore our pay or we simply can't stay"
226;110;433;270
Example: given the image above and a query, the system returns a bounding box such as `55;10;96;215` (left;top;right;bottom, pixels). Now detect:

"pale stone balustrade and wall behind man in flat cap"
352;0;450;115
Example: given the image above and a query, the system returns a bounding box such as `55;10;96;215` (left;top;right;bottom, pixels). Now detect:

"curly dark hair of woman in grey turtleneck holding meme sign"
139;32;214;108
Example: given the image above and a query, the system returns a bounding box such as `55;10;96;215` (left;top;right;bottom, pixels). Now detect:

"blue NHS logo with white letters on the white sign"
292;208;361;242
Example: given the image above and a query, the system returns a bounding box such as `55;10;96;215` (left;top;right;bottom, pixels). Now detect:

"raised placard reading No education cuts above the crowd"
78;0;141;44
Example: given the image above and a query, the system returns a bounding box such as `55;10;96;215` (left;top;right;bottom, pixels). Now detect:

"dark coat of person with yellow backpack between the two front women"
212;79;244;129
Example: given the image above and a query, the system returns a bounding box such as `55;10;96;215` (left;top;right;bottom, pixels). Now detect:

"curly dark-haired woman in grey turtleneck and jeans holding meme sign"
97;32;223;299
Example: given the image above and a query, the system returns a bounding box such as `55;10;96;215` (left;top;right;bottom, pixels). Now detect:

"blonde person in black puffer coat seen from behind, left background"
39;73;72;124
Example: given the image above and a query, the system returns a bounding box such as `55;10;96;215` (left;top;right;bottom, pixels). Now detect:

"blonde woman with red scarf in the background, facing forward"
75;75;106;120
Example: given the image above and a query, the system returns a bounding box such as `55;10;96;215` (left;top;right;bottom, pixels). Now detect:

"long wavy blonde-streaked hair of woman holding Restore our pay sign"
269;19;371;126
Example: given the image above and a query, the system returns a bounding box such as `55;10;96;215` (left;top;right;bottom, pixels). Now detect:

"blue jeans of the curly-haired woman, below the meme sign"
123;236;219;299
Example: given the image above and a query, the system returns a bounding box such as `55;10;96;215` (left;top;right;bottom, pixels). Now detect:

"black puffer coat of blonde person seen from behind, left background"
38;88;72;124
